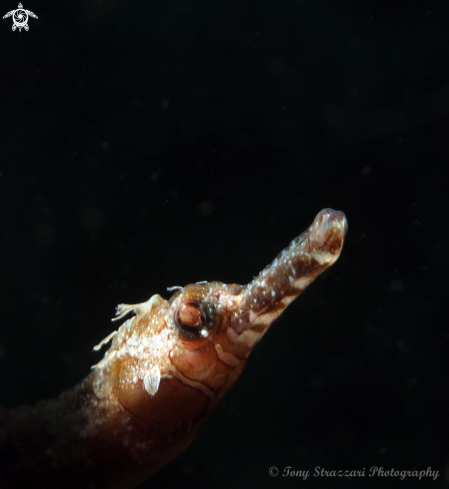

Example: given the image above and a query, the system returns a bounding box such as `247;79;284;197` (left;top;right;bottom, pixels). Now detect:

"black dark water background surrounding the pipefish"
0;0;449;488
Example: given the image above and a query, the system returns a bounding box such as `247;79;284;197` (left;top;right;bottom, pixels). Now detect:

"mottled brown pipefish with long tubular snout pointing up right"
0;209;347;489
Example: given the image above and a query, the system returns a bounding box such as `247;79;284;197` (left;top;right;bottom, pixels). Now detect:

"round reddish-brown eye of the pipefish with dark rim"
175;301;215;340
